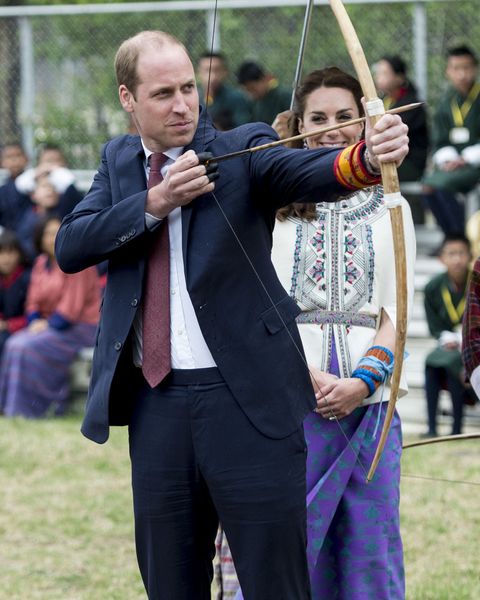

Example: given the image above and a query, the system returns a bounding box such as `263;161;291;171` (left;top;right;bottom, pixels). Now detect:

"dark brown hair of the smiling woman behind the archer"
277;67;364;221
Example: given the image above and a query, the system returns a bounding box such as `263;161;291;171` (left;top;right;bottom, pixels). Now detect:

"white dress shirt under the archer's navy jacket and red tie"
133;140;216;369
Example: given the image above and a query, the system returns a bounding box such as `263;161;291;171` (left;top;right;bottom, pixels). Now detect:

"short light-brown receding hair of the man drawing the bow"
115;31;188;97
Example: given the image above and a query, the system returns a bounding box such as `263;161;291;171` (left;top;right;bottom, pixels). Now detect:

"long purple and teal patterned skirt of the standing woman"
227;404;405;600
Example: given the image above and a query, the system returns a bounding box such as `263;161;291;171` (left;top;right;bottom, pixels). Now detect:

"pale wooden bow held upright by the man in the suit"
329;0;407;482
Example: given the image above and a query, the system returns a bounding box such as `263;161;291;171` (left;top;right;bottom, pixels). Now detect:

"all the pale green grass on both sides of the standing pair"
0;417;480;600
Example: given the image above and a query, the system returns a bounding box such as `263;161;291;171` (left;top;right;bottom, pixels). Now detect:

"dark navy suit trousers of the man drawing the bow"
129;369;311;600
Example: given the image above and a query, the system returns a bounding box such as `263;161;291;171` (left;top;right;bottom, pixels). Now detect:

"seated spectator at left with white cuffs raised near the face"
15;146;82;218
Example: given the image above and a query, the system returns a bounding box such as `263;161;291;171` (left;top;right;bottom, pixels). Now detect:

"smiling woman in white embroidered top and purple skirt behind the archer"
217;67;415;600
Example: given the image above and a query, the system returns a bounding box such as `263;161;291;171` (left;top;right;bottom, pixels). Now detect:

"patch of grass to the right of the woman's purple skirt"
401;440;480;600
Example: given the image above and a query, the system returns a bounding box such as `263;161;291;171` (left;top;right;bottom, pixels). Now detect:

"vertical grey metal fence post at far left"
18;17;35;159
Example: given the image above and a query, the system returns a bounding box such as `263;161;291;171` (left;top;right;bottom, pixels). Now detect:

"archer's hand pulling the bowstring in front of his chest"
145;150;216;219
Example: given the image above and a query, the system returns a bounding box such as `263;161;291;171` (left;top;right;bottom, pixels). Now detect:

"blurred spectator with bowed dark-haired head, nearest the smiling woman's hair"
237;61;292;125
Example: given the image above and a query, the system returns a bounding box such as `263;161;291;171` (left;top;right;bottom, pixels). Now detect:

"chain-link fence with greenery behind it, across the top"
0;0;480;169
